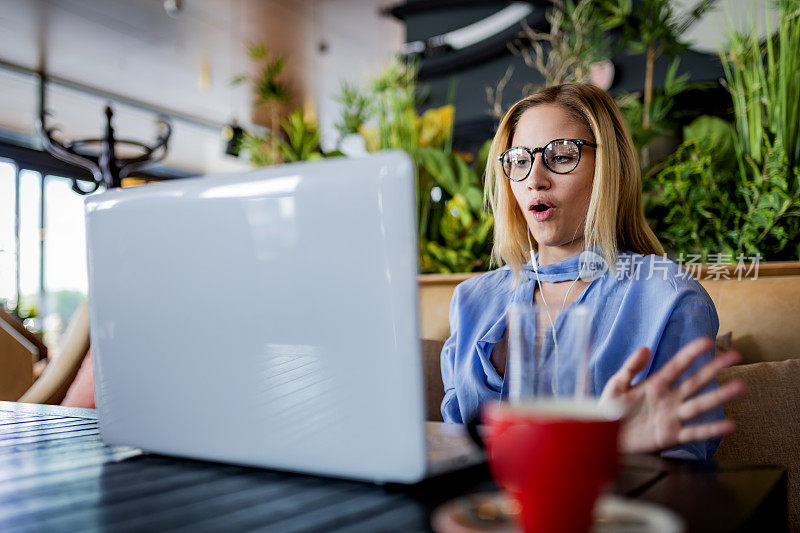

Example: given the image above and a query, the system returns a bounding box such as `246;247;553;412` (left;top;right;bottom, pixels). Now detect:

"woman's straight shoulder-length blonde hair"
484;83;664;283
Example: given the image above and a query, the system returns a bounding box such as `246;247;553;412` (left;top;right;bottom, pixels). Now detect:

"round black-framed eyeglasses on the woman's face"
497;139;597;181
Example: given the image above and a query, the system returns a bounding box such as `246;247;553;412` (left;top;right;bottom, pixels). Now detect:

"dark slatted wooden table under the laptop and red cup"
0;402;786;532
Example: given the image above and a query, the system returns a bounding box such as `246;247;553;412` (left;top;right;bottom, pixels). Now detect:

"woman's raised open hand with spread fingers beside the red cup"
601;337;745;453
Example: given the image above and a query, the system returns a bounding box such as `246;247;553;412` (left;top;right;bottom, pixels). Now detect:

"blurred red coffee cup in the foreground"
483;399;620;533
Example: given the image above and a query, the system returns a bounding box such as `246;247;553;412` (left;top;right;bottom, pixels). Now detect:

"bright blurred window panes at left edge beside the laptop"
0;154;96;355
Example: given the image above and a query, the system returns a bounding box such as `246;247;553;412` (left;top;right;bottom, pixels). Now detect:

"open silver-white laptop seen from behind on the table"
86;152;479;483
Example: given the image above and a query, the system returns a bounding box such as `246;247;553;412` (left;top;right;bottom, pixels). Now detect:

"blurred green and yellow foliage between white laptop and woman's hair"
339;60;492;274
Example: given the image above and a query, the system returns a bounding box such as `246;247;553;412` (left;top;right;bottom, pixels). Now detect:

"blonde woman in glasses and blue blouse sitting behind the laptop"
442;84;744;459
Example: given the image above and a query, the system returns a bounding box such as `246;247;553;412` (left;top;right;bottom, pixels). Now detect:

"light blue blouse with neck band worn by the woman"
441;252;723;459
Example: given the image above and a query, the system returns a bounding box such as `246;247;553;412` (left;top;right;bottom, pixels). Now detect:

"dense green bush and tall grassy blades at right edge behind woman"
645;0;800;260
